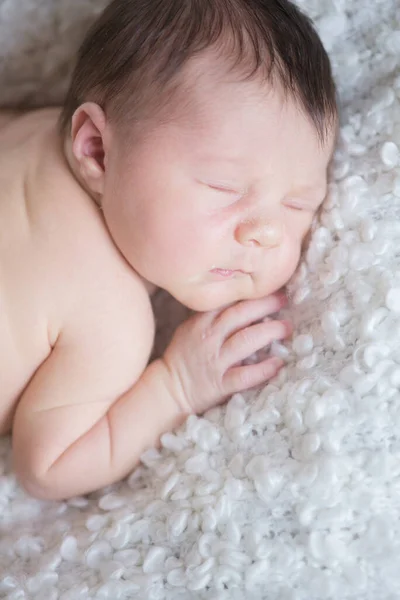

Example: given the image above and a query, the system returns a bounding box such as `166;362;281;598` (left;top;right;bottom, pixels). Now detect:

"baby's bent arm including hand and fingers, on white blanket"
13;296;290;499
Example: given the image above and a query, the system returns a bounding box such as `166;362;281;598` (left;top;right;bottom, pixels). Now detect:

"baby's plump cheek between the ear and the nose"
105;152;225;274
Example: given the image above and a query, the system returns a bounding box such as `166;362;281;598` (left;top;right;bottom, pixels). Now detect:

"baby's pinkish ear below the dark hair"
71;102;106;195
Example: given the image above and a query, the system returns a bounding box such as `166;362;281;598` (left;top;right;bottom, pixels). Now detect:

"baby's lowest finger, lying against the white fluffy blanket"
223;357;285;395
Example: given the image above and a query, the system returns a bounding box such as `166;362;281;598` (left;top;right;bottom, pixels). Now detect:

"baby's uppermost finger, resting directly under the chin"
213;292;287;339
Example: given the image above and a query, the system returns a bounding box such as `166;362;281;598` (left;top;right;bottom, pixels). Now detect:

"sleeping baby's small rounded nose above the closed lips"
235;219;283;248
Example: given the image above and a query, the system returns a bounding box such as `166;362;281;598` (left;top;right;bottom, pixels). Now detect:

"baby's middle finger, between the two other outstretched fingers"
220;321;292;368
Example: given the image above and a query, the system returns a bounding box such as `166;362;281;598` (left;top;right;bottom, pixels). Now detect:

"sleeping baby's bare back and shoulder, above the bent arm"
0;109;153;433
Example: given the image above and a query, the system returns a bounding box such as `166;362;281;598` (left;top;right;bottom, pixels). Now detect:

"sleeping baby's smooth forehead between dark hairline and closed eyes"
170;56;335;178
